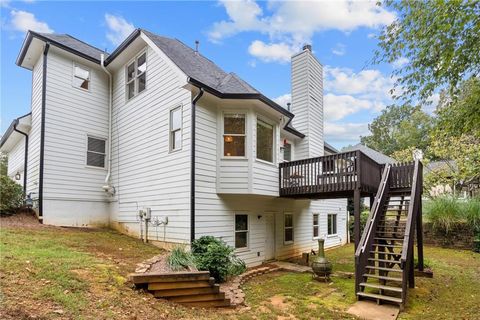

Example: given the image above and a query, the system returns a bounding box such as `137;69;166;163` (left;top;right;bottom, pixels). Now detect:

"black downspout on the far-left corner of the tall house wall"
38;42;50;217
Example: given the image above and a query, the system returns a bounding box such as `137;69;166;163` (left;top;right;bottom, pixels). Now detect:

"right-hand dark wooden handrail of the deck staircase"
400;160;423;269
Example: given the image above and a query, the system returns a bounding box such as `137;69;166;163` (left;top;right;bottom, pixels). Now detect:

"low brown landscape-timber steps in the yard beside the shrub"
130;271;230;308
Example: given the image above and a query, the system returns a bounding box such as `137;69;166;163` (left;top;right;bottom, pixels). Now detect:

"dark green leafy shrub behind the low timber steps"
192;236;246;282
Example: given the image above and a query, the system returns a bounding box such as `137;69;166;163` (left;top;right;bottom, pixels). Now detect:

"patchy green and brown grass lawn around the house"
0;215;480;320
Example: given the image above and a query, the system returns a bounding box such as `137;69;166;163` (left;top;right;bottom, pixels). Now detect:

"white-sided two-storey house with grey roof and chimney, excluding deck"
0;29;347;265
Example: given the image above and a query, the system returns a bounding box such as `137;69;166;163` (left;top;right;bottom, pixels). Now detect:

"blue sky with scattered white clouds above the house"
0;0;405;148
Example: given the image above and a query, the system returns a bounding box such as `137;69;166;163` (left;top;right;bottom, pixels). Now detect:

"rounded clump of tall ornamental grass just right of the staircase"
423;196;464;234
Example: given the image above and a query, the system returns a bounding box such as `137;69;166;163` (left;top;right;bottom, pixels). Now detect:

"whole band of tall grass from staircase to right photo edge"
423;196;480;234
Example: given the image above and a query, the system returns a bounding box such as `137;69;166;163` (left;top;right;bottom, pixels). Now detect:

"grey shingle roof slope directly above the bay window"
142;29;259;94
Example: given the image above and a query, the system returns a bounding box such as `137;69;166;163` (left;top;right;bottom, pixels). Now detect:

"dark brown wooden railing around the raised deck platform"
279;151;383;196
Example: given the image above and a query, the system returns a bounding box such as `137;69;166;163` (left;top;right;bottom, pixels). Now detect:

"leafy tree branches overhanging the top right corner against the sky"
373;0;480;102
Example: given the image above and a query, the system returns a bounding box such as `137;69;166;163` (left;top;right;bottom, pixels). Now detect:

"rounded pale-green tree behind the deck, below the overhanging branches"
361;105;434;155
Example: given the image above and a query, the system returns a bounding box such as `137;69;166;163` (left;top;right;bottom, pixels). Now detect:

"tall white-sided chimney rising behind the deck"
292;44;323;160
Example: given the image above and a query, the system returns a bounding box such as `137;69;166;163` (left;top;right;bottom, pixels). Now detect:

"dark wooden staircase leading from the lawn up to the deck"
355;161;423;308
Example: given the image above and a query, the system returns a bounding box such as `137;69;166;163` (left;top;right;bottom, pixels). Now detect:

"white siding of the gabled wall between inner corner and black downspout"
111;43;192;243
